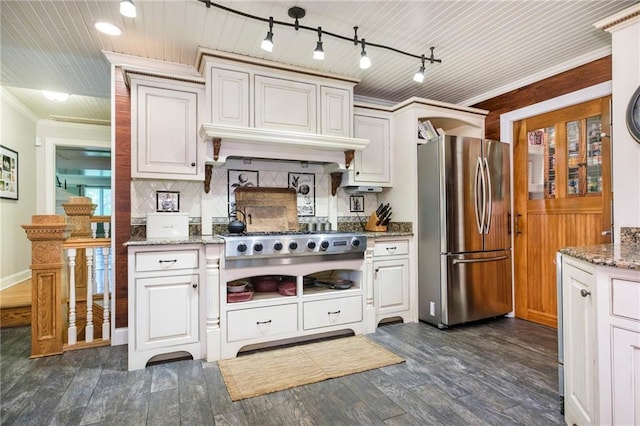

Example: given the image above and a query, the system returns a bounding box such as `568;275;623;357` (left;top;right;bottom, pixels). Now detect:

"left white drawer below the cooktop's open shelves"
227;303;298;342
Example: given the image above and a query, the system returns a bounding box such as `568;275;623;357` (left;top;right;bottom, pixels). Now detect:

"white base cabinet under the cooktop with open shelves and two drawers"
219;259;366;359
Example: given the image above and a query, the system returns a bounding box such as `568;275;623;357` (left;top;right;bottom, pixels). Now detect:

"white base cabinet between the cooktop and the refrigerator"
373;239;411;324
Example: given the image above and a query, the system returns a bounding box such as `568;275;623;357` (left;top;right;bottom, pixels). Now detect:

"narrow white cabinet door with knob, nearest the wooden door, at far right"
562;258;597;425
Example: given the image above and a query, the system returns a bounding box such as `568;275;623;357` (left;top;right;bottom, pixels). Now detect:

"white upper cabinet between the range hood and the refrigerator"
342;108;392;186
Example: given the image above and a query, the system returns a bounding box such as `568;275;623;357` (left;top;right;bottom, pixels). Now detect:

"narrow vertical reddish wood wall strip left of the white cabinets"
113;68;131;328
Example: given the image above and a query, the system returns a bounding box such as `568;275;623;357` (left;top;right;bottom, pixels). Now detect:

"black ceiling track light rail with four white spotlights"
198;0;442;83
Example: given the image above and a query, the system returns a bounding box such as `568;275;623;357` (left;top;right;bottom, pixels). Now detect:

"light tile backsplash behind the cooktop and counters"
131;159;378;224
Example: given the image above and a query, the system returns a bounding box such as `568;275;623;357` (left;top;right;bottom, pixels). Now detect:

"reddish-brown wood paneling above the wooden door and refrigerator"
471;55;612;140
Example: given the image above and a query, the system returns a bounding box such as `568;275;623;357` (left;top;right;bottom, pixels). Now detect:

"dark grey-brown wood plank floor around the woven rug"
0;318;564;426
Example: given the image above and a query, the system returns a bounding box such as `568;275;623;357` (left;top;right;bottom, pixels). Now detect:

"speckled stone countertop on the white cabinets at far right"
560;243;640;270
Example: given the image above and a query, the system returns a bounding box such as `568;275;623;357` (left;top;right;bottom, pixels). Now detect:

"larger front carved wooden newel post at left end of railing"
22;215;71;358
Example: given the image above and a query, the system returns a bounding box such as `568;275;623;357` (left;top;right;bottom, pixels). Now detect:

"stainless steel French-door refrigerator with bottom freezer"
417;136;513;328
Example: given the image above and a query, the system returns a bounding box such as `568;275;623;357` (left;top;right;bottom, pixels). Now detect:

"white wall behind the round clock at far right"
608;13;640;241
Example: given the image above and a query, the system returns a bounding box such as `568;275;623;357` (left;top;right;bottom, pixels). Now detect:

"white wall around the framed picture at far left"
0;88;37;289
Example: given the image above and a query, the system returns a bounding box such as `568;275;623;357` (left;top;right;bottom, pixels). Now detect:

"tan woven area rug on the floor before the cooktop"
218;336;404;401
